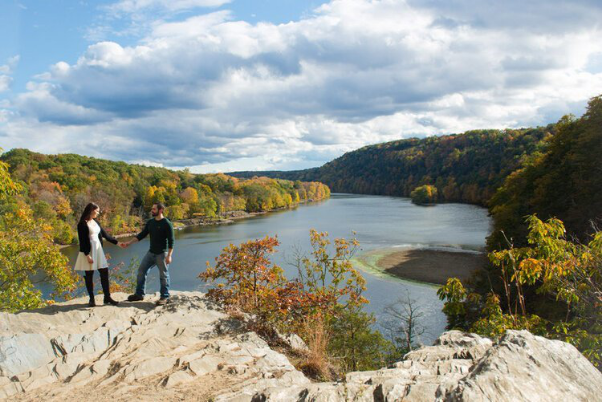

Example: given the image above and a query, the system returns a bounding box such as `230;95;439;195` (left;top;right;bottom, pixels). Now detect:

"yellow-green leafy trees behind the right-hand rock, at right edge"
439;216;602;366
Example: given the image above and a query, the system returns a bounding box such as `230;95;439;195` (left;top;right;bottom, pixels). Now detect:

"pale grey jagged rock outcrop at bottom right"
254;332;602;402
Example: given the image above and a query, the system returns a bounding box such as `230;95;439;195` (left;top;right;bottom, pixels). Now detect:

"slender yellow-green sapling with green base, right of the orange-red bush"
295;230;392;372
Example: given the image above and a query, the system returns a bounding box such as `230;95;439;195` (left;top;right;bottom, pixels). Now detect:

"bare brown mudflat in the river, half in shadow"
355;249;487;285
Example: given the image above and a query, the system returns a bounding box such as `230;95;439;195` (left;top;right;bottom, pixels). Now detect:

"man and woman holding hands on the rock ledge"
75;203;175;307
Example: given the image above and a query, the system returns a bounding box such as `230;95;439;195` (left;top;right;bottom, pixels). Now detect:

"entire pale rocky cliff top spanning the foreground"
0;293;602;401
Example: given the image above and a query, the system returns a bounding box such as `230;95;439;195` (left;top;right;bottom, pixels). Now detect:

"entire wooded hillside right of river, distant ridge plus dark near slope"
231;96;602;249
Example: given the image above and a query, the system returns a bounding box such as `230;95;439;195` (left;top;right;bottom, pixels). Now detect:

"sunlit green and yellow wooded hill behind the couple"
0;149;330;244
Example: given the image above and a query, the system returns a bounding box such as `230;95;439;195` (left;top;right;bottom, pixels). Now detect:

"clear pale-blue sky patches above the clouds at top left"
0;0;326;91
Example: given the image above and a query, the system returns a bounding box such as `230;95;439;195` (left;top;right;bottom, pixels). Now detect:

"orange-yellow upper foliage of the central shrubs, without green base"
199;230;368;334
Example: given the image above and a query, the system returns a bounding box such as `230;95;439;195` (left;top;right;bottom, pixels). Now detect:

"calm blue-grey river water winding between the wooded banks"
64;194;491;343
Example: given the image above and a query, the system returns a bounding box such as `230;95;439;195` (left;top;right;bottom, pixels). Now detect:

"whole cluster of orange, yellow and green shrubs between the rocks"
200;230;391;379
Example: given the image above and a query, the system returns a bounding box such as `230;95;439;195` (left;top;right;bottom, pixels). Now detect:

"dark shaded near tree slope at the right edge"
489;97;602;249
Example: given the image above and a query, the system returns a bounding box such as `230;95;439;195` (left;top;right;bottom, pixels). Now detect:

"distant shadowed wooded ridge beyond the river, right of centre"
230;125;556;205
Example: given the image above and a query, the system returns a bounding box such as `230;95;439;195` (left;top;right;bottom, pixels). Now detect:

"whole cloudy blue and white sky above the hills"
0;0;602;173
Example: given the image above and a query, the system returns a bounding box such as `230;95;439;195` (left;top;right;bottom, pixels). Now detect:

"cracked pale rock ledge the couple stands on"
0;293;309;401
